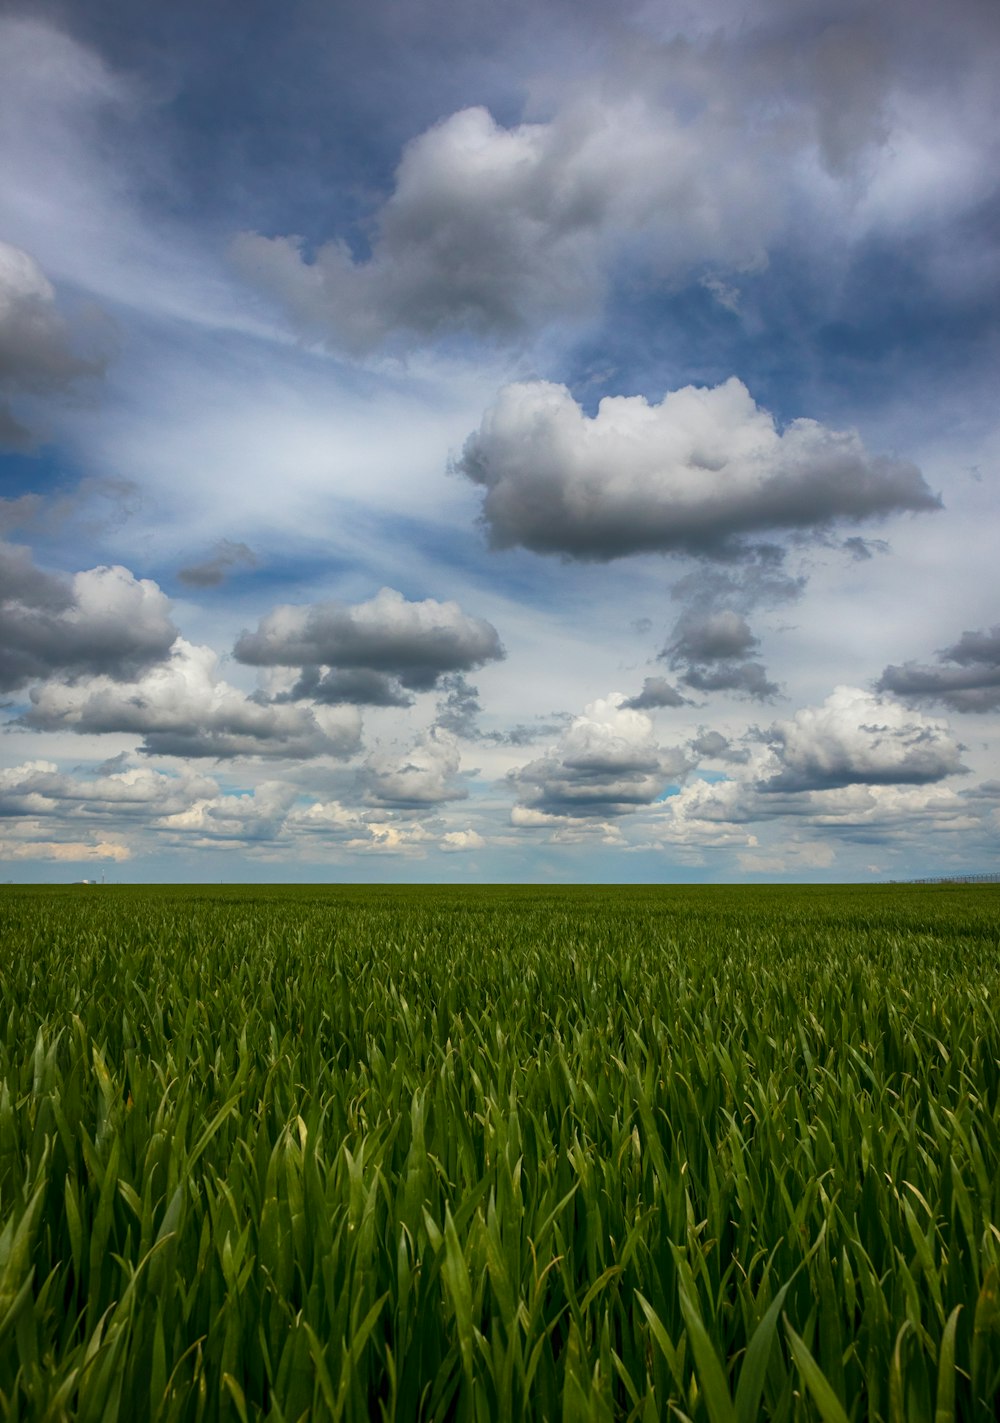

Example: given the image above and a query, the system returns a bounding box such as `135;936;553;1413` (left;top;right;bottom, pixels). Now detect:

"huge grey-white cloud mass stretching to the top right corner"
235;0;997;350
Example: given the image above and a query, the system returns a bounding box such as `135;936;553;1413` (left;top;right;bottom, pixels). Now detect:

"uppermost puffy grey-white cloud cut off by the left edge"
0;242;104;445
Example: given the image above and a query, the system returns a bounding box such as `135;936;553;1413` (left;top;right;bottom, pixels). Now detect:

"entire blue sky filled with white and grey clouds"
0;0;1000;881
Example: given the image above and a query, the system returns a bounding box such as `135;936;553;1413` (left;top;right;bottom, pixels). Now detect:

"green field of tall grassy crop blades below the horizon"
0;887;1000;1423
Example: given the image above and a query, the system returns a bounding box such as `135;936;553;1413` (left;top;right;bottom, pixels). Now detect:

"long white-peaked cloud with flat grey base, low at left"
21;638;361;760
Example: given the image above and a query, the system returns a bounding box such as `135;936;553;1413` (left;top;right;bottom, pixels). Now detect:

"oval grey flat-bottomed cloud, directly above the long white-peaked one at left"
235;588;504;706
